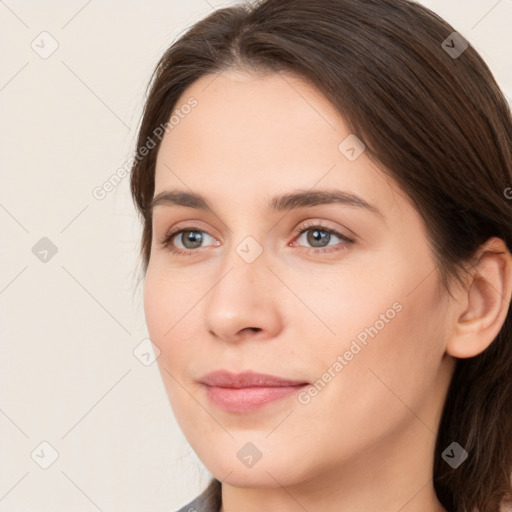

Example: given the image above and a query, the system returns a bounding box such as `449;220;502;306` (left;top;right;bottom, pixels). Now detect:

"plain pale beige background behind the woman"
0;0;512;512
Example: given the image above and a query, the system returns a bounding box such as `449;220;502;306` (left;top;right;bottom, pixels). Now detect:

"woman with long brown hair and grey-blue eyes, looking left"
131;0;512;512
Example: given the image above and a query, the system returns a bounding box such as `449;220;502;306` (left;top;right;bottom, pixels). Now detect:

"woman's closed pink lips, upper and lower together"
199;370;309;412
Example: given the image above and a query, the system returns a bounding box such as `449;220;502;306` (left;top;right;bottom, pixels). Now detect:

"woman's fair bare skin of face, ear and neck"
144;70;512;512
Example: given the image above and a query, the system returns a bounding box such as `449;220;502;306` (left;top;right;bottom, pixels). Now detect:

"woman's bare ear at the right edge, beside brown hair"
446;237;512;358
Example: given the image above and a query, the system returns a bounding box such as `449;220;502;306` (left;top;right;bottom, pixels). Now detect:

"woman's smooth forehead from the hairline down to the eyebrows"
155;71;408;218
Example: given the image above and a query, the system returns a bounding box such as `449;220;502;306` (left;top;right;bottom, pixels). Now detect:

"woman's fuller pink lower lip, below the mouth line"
205;384;308;412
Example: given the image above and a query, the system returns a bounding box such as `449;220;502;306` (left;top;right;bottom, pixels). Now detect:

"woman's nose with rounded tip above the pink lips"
204;245;282;342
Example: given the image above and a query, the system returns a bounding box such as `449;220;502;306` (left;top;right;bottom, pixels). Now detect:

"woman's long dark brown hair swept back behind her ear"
131;0;512;512
